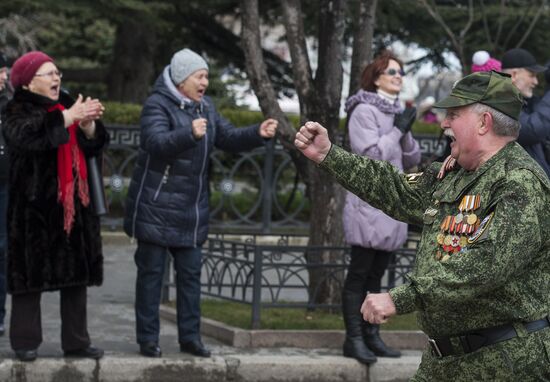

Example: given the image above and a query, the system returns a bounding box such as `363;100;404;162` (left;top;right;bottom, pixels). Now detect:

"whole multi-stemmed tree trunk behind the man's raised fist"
241;0;376;304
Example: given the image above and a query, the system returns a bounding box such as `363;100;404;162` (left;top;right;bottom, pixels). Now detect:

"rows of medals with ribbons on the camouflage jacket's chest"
435;195;481;261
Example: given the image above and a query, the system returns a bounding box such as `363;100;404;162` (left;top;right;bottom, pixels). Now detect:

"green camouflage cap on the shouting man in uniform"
433;71;523;121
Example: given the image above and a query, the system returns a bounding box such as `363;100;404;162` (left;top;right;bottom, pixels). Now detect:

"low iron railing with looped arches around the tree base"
163;235;417;329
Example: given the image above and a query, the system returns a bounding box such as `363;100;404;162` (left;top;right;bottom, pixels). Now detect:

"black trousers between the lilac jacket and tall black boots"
344;245;390;294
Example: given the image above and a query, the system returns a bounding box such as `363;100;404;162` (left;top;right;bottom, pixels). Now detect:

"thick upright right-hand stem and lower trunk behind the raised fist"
305;0;346;304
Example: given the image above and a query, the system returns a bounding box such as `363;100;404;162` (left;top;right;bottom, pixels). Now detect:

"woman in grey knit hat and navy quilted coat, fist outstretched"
124;49;277;357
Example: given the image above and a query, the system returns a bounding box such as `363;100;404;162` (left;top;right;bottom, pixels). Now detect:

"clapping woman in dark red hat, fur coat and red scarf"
2;51;108;361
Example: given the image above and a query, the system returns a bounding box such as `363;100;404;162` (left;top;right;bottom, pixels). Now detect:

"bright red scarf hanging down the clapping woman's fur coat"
48;103;90;235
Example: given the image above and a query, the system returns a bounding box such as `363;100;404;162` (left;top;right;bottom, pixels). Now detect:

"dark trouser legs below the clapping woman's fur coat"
10;286;90;351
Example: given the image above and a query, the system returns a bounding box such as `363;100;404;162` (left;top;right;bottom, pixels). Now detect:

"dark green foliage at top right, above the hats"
375;0;550;72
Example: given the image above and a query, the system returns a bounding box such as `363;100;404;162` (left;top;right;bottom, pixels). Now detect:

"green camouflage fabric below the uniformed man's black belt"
411;327;550;382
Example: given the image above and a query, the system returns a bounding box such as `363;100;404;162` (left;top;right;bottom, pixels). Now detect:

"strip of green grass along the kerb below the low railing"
169;299;419;330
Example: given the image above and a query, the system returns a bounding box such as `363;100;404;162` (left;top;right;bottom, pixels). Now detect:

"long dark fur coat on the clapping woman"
3;89;108;294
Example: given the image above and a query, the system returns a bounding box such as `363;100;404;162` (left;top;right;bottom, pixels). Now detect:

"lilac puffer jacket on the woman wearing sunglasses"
343;90;420;251
